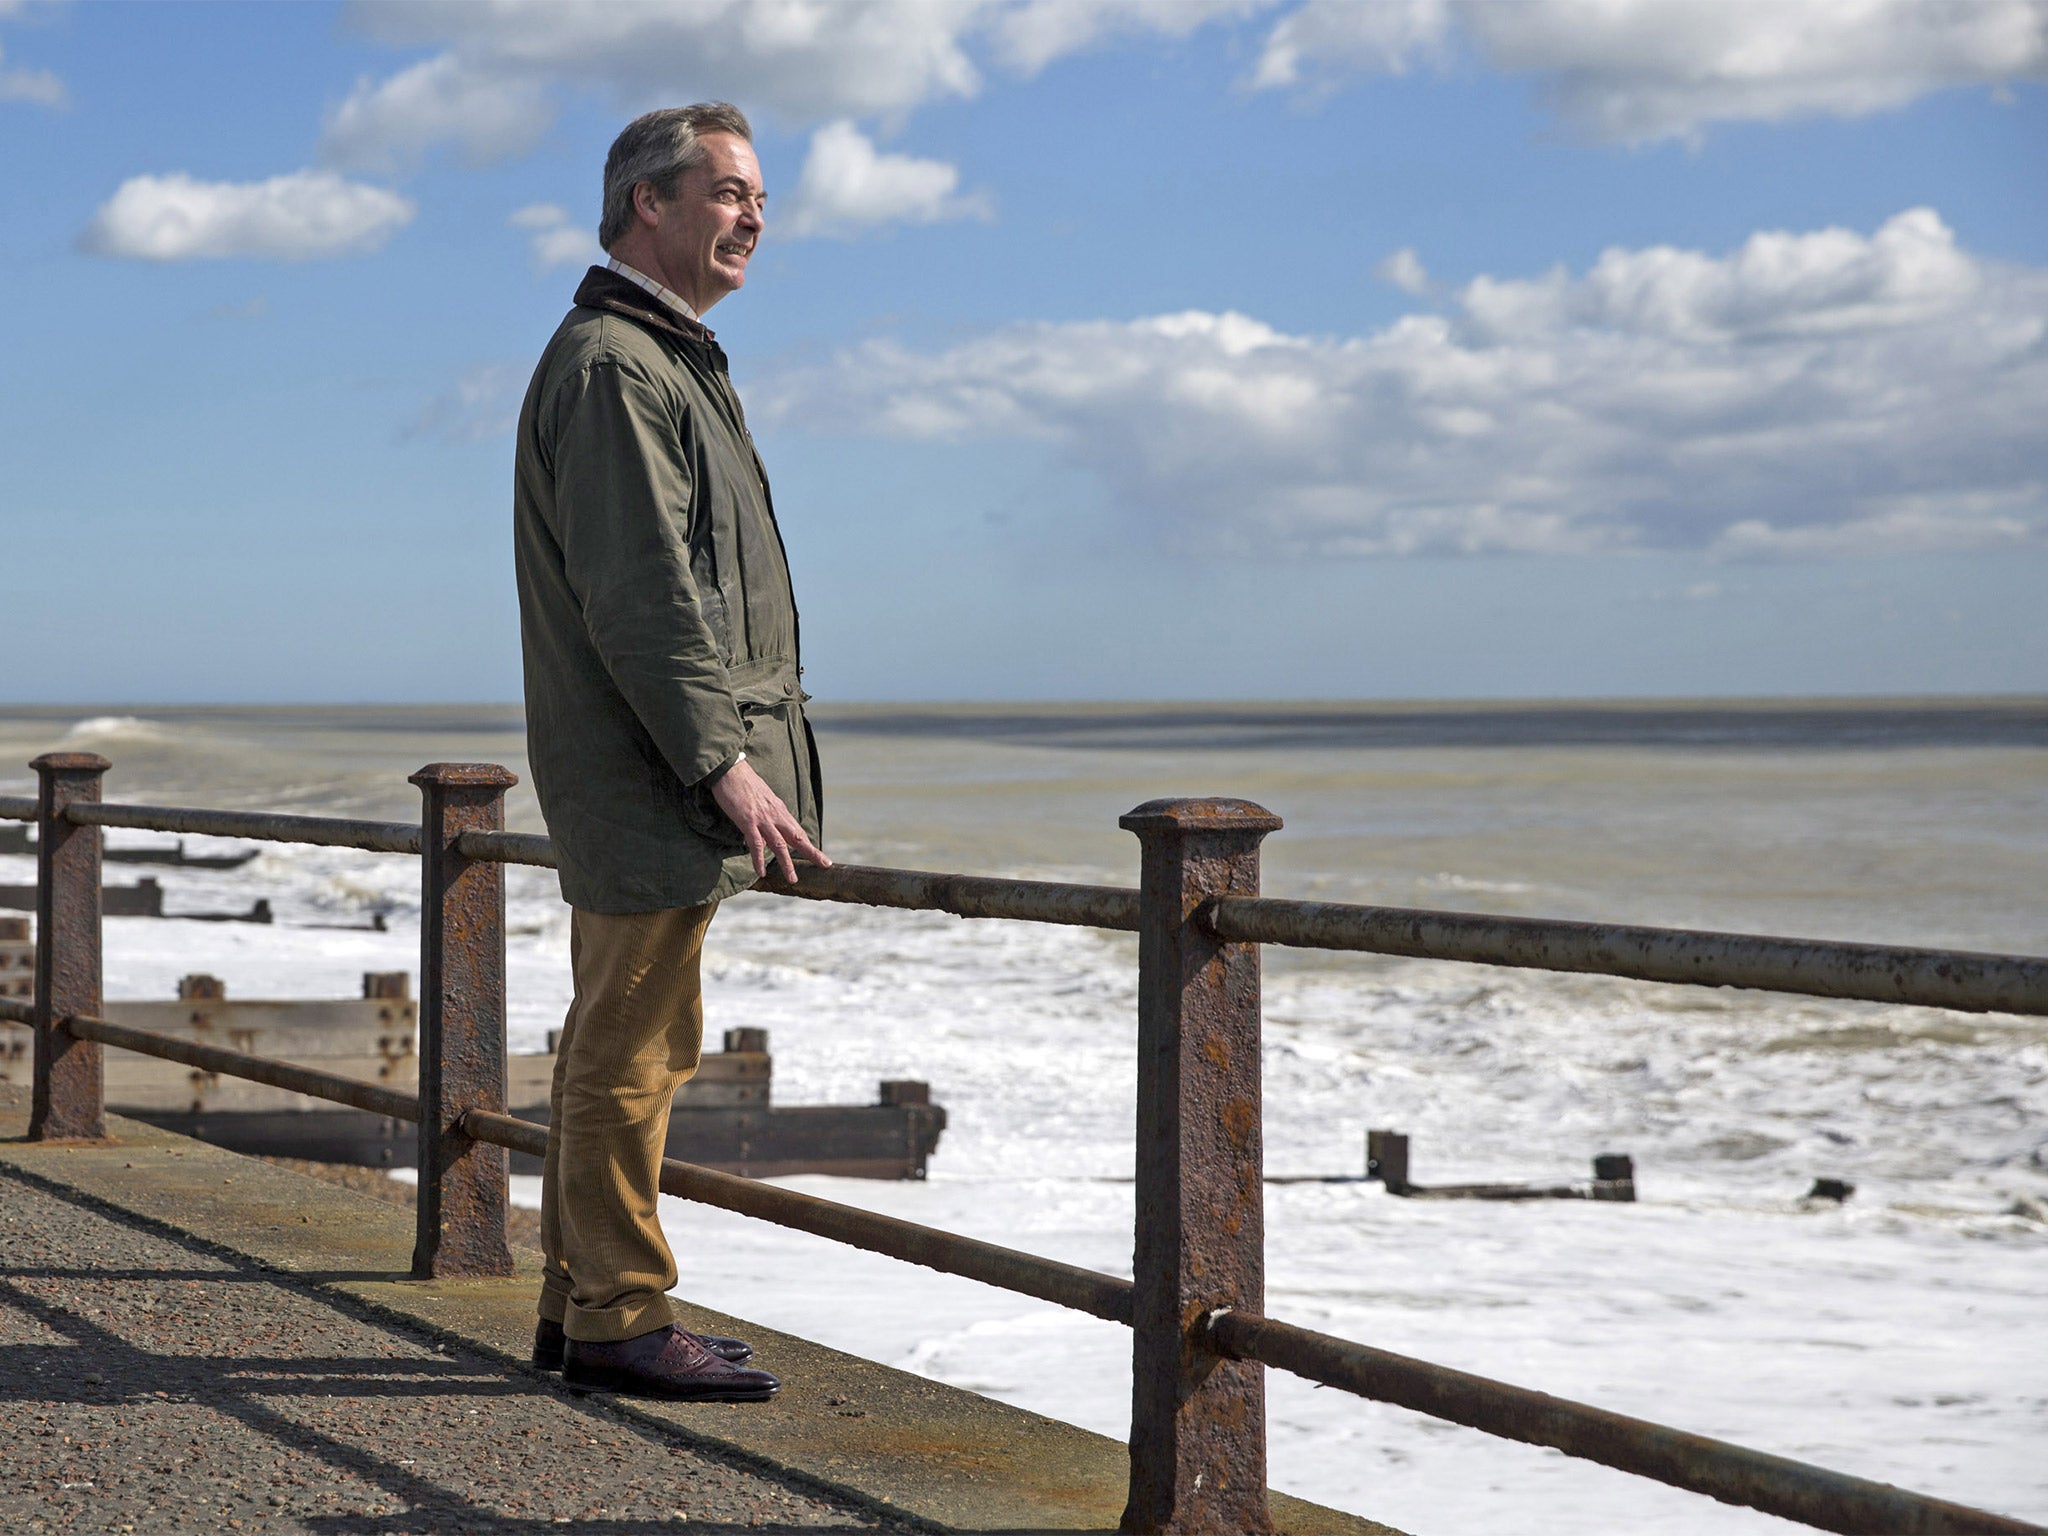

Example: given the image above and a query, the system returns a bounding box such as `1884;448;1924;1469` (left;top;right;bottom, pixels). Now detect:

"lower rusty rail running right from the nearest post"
1206;1313;2040;1536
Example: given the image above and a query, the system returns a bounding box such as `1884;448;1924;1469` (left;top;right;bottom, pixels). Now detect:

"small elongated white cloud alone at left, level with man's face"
84;170;414;262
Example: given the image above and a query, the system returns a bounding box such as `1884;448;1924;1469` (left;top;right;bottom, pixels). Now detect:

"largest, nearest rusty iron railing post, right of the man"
1118;801;1280;1536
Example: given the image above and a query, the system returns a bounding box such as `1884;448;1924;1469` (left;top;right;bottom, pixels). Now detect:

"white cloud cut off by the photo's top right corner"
1251;0;2048;143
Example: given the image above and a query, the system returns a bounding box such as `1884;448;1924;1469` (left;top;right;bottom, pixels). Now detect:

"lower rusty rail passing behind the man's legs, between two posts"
463;1110;1130;1327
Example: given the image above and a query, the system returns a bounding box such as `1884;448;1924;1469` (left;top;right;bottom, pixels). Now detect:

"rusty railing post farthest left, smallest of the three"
29;752;113;1141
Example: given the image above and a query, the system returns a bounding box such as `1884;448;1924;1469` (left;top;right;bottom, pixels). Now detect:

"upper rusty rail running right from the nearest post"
1202;895;2048;1014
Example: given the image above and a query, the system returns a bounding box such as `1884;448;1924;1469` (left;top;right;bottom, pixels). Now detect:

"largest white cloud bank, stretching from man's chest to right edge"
756;209;2048;557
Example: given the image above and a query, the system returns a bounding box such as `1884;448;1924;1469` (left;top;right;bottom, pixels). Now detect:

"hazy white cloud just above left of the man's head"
319;53;555;172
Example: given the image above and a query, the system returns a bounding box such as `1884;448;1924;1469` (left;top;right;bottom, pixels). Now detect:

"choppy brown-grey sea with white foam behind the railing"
0;698;2048;1536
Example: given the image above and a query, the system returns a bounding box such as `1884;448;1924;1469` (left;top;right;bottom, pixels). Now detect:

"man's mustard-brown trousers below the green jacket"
541;903;717;1343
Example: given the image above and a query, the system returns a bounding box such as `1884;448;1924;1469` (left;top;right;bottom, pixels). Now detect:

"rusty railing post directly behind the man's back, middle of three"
410;762;518;1280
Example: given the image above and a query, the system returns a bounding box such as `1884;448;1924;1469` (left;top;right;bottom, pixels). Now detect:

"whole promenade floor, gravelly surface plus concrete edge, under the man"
0;1087;1393;1536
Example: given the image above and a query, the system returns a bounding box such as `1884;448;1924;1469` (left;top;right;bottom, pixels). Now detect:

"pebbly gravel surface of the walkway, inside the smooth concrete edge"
0;1171;899;1536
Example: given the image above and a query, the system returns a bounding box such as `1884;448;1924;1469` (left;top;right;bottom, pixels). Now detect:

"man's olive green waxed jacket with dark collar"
512;266;821;911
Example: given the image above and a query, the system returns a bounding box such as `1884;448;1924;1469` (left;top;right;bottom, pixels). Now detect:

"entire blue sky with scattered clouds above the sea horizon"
0;0;2048;702
